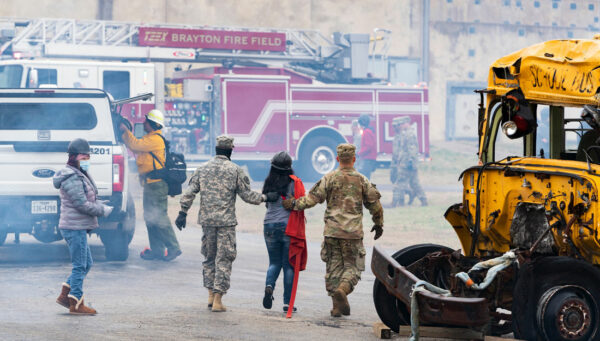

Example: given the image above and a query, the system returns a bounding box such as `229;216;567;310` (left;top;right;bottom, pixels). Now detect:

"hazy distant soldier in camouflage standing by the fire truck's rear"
390;116;427;207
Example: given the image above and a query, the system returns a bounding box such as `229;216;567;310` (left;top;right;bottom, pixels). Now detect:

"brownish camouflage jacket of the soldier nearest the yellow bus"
294;167;383;239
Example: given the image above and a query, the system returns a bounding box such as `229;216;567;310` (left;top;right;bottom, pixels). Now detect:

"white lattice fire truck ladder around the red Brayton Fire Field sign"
0;18;352;62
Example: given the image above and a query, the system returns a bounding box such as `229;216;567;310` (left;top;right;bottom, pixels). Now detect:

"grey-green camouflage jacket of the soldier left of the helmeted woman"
180;155;263;226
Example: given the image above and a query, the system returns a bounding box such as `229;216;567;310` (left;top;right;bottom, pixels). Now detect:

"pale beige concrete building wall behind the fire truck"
0;0;600;142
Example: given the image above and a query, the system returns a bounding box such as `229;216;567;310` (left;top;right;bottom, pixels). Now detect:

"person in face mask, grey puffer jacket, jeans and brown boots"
52;139;113;315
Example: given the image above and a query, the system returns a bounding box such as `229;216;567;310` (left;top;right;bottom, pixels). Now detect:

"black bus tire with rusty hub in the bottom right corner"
512;257;600;341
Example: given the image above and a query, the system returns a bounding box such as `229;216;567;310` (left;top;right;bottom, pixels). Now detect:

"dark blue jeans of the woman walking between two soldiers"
264;222;294;304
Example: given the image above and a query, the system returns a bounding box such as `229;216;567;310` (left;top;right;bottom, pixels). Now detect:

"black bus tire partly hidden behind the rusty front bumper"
373;244;452;333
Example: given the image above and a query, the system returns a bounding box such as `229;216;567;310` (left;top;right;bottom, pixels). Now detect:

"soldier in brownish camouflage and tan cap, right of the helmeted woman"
283;144;383;317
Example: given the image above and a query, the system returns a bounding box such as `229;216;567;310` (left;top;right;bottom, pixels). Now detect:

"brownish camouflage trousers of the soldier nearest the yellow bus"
321;237;366;296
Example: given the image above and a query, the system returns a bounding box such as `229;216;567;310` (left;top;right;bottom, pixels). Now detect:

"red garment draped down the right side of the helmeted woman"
285;175;308;271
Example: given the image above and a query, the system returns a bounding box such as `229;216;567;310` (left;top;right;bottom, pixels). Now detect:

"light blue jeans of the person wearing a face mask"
60;229;93;299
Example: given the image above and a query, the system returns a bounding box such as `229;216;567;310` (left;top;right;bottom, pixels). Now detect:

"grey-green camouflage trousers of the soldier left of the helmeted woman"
201;226;237;294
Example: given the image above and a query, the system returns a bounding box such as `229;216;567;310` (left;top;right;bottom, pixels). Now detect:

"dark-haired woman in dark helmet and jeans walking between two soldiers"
262;151;296;312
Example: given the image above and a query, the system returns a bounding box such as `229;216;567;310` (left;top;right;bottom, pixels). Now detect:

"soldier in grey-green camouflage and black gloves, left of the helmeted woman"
175;135;278;312
